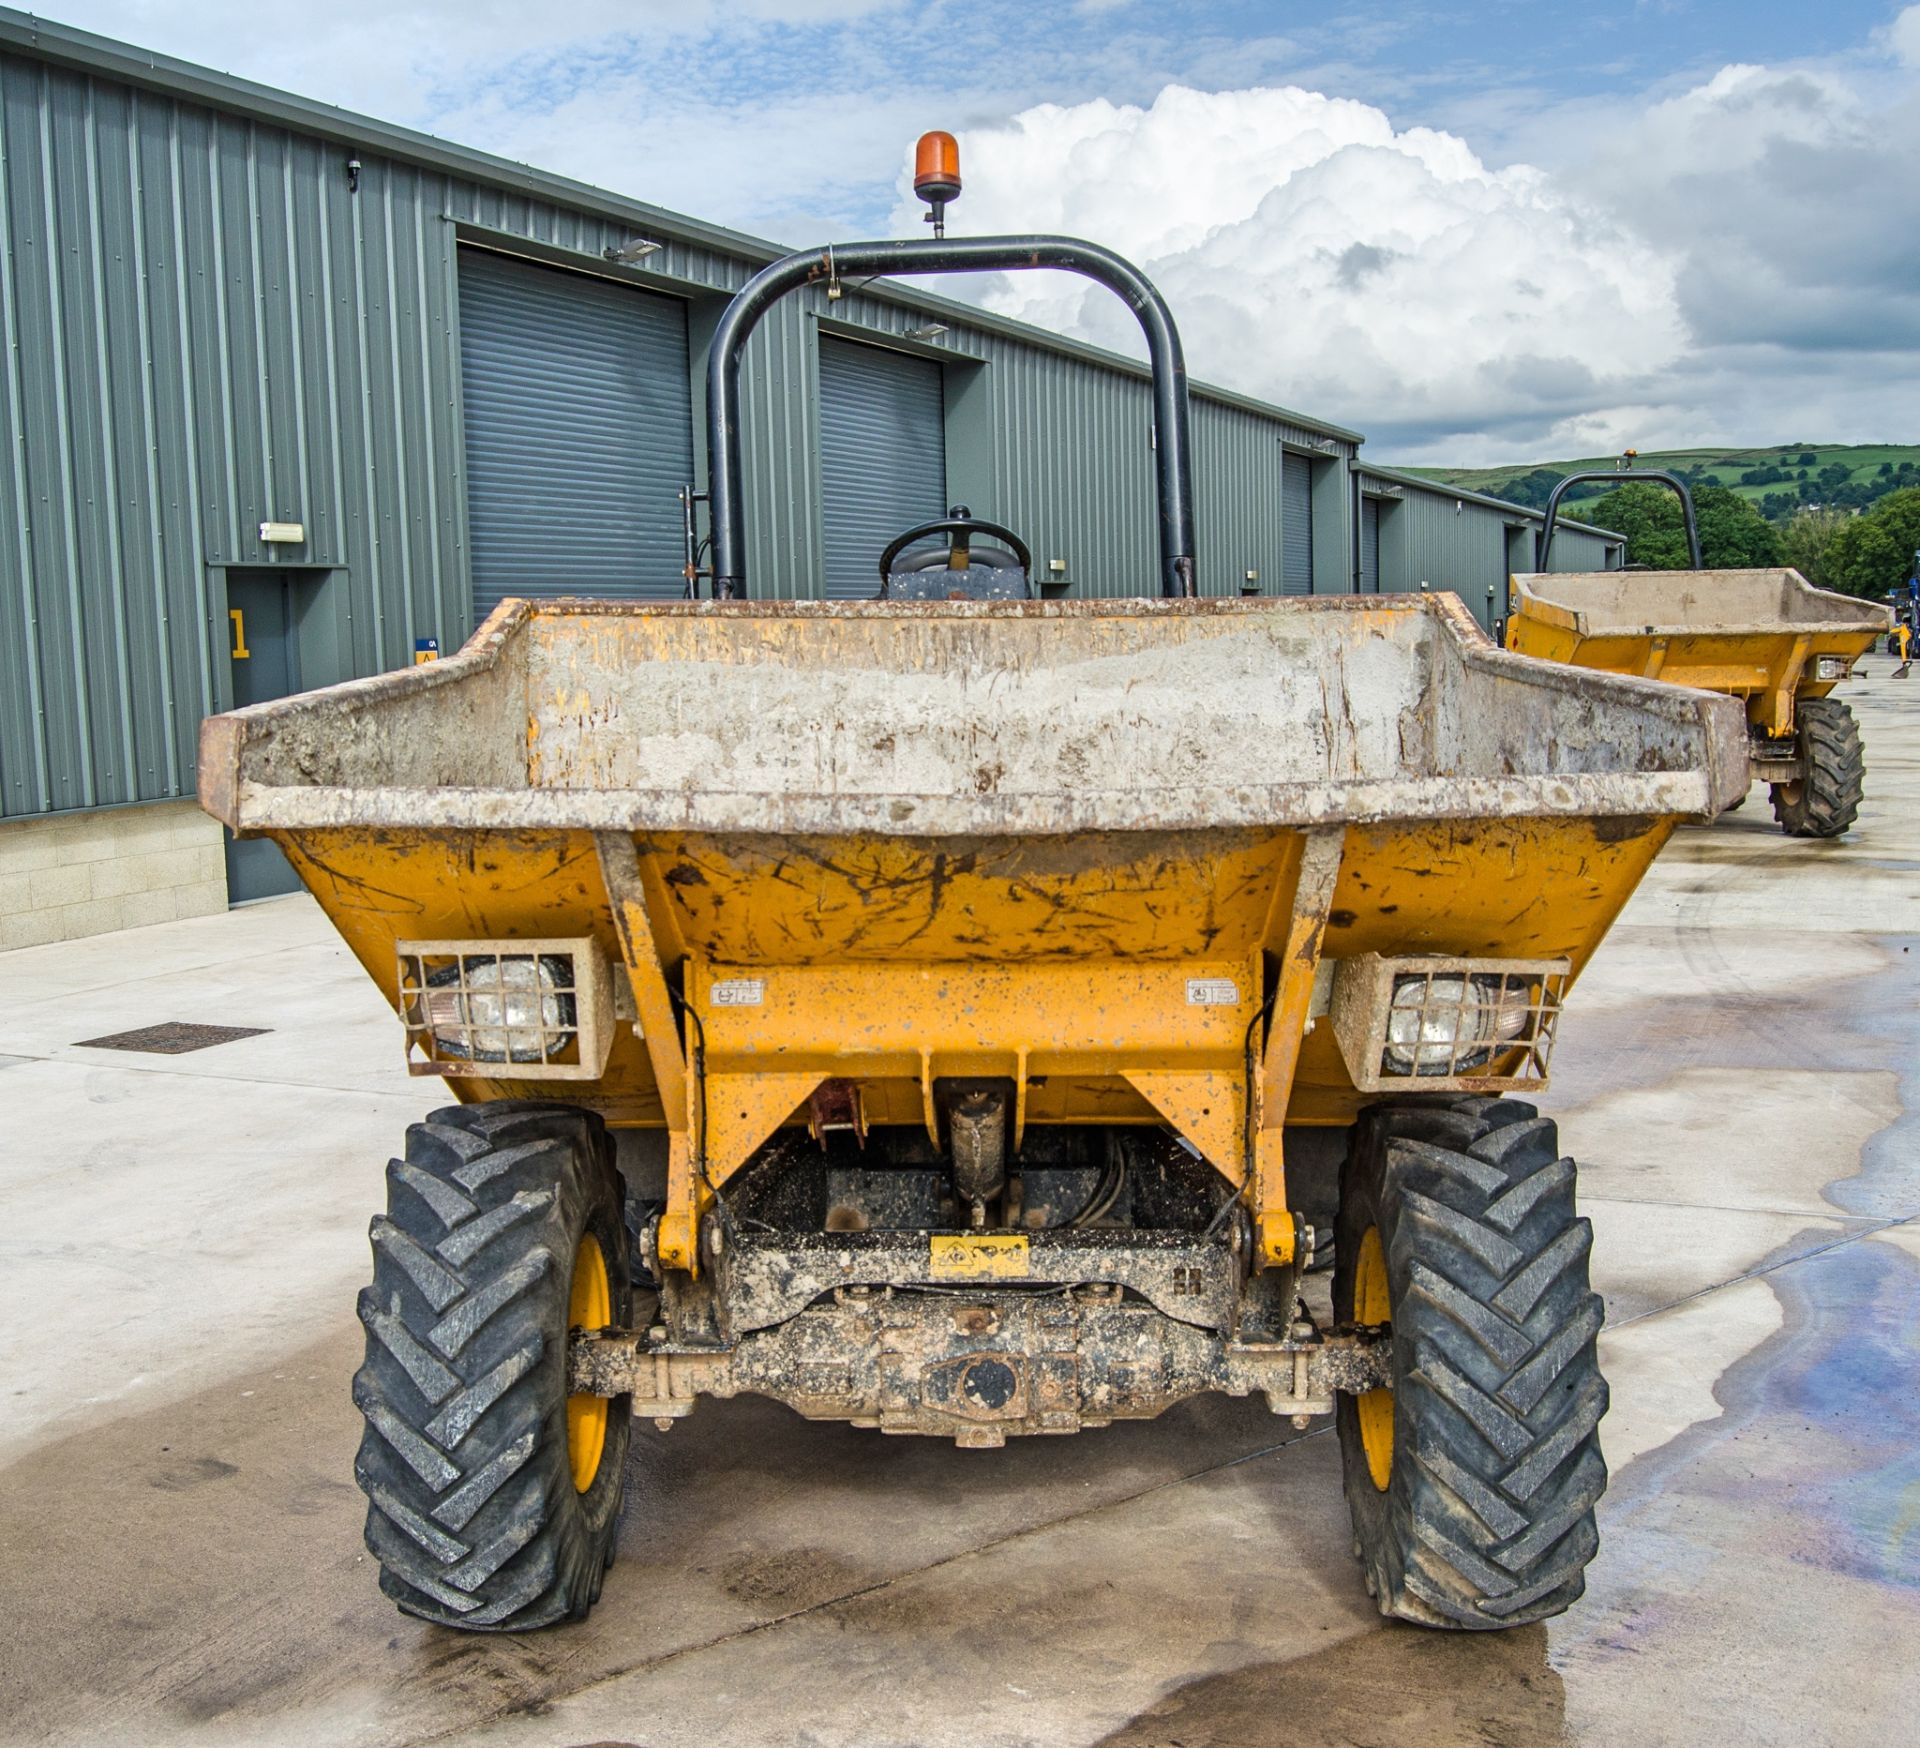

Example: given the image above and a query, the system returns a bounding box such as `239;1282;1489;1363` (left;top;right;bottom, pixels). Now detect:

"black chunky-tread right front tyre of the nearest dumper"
1334;1097;1607;1629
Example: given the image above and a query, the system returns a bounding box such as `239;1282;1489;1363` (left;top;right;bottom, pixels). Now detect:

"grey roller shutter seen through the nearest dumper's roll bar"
820;334;947;601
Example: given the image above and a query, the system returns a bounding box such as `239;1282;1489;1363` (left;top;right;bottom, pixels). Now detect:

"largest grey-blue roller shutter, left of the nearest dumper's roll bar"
461;250;693;622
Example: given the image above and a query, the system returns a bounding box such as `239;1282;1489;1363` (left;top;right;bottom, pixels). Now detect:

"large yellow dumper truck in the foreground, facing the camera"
202;170;1747;1629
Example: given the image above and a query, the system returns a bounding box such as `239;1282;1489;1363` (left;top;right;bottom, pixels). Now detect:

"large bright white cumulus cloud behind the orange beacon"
900;86;1686;455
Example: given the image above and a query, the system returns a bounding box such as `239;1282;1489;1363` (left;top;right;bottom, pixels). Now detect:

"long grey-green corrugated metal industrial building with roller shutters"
0;10;1622;949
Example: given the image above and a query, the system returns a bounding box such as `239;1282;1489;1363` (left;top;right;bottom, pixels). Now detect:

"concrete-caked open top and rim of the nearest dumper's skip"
202;595;1743;836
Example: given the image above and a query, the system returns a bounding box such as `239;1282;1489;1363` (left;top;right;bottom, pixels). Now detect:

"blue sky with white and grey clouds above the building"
46;0;1920;465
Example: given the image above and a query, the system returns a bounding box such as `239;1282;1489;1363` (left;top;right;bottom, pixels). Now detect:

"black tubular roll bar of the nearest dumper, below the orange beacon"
707;236;1196;599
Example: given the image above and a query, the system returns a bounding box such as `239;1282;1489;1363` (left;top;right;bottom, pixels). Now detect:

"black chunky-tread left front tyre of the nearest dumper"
353;1101;632;1631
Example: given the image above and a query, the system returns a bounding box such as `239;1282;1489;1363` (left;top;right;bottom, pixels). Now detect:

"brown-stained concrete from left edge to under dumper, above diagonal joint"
0;1322;1320;1744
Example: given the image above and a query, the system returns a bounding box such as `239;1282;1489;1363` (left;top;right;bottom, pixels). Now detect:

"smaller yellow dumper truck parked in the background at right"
1507;469;1891;838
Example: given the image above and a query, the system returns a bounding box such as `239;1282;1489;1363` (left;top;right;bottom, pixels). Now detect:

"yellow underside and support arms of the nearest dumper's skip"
273;818;1674;1274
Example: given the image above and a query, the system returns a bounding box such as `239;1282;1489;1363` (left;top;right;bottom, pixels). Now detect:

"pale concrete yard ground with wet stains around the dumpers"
0;657;1920;1748
